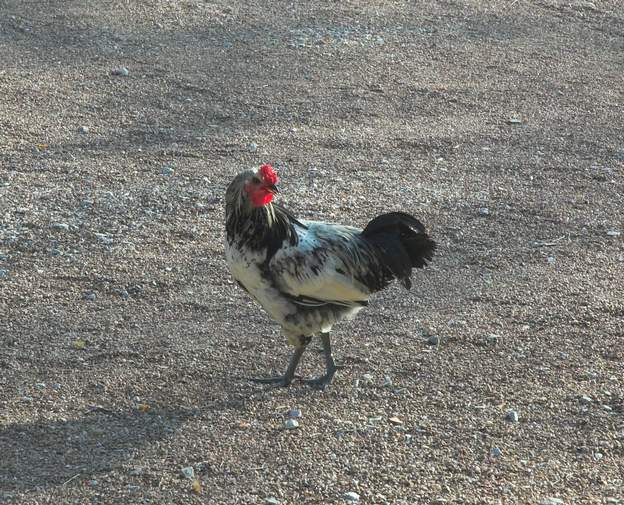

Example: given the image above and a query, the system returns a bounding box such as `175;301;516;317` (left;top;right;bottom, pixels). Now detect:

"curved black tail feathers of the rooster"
362;212;436;289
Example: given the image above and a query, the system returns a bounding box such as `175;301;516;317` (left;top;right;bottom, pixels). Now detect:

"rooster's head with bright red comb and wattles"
225;163;279;208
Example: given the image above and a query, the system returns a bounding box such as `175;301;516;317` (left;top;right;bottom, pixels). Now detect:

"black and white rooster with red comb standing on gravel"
225;164;436;388
